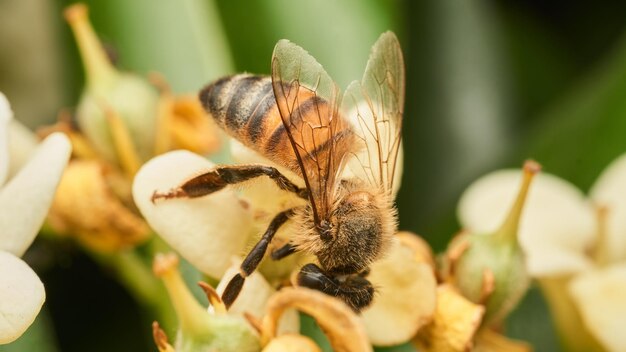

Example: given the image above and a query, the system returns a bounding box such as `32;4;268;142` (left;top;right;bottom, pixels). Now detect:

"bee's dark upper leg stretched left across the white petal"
152;165;309;203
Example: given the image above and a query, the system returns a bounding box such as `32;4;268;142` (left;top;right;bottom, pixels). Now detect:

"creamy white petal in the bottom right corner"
570;264;626;351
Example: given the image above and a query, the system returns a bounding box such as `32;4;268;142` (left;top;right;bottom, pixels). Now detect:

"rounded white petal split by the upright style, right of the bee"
457;170;596;274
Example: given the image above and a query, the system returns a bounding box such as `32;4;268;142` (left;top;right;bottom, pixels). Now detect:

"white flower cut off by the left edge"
0;93;71;344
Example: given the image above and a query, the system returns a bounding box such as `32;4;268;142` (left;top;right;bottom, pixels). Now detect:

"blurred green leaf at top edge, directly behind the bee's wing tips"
219;0;398;89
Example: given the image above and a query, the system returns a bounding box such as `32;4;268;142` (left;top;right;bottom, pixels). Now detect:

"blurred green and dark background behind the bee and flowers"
0;0;626;351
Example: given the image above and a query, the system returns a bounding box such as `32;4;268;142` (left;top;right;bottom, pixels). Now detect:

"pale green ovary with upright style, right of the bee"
447;161;540;326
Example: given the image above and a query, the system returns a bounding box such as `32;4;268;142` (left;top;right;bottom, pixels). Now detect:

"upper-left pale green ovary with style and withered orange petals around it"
40;4;219;252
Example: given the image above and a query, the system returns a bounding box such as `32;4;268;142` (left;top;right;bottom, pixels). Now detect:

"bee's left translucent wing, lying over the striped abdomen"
272;40;354;224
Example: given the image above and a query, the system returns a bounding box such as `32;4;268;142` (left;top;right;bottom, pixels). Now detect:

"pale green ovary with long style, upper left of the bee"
65;4;158;170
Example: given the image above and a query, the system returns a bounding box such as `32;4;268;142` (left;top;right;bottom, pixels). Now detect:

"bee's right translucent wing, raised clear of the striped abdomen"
341;32;404;194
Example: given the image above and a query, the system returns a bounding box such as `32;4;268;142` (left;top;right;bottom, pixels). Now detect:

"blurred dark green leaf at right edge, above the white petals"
522;32;626;190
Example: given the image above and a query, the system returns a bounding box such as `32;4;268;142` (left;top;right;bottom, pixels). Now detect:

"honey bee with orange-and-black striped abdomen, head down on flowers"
153;32;404;311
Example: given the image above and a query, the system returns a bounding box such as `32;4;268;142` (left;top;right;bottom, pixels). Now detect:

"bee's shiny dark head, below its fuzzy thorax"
298;264;374;312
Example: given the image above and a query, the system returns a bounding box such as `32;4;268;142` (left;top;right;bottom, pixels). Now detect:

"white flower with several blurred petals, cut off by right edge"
458;155;626;351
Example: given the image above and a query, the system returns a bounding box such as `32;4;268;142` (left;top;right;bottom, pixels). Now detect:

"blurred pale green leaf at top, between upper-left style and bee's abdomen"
81;0;230;92
